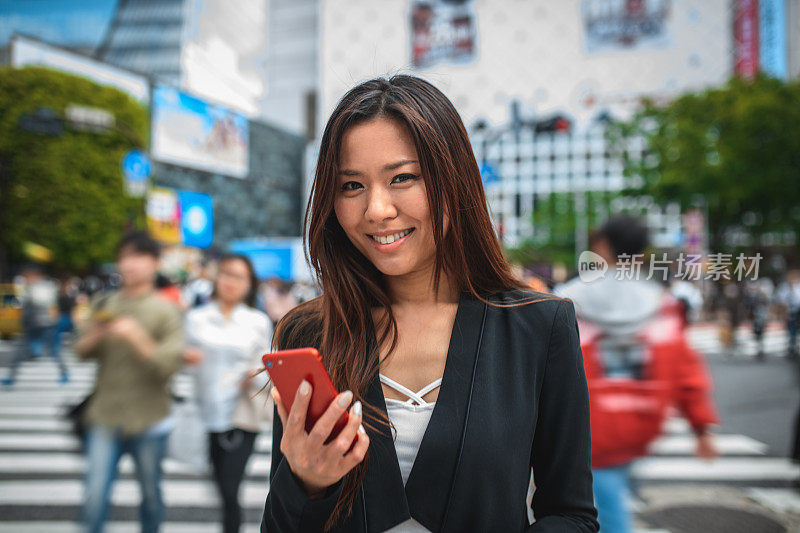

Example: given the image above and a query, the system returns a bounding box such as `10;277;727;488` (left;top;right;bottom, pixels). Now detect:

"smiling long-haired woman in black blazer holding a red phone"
261;75;598;532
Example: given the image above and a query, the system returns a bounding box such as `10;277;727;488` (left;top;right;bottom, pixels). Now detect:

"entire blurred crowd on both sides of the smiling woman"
2;225;800;532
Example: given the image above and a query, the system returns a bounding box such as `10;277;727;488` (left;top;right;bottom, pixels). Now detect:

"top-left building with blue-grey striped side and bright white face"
95;0;267;117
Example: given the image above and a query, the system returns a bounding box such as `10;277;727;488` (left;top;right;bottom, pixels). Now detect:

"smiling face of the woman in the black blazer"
334;117;448;276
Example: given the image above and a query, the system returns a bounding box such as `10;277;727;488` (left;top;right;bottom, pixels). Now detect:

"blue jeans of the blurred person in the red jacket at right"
592;463;633;533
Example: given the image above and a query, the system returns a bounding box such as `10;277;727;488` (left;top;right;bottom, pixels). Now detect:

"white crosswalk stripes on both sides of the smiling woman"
0;330;800;533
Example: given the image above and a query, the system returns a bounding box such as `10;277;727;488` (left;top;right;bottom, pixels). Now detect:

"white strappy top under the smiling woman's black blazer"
379;374;442;533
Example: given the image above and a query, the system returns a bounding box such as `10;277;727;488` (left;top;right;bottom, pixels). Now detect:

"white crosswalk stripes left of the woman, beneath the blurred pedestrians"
0;343;272;533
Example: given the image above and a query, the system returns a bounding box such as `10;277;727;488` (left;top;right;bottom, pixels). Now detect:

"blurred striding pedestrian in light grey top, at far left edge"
3;264;61;388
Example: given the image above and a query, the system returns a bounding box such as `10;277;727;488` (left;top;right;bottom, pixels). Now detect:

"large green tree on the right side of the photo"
612;76;800;251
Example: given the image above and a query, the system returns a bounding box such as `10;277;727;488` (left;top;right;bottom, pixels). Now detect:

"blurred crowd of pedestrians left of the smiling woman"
3;232;316;532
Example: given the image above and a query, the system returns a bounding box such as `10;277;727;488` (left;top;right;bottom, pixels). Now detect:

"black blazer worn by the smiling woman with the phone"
261;290;599;533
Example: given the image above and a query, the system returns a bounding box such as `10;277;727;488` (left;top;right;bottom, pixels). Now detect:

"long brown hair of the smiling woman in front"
272;75;560;531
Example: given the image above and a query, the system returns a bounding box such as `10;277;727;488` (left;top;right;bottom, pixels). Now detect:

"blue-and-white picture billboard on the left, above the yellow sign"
151;87;250;178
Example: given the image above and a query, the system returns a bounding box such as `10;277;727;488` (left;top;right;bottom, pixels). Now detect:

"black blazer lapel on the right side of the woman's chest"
406;292;486;532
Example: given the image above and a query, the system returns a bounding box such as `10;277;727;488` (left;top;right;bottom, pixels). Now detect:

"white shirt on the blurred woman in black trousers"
185;301;272;431
